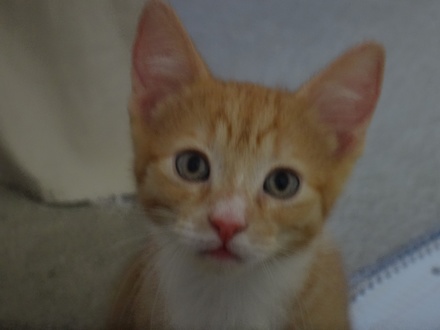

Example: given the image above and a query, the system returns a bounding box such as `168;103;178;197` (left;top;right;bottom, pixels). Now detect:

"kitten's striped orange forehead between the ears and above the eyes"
160;83;304;150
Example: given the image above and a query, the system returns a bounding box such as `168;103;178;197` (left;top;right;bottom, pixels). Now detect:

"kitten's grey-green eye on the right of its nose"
263;168;300;199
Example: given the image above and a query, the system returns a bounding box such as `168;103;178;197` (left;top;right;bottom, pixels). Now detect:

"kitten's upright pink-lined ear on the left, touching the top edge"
132;0;209;116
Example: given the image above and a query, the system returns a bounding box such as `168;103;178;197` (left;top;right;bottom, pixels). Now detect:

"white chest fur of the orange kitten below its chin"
153;244;313;330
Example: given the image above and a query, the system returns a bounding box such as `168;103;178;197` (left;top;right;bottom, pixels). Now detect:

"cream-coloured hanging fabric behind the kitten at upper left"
0;0;143;202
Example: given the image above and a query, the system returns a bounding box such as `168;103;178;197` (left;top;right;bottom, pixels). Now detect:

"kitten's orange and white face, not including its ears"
134;82;330;270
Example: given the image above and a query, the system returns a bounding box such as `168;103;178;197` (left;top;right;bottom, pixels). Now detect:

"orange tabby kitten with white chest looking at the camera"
110;0;384;330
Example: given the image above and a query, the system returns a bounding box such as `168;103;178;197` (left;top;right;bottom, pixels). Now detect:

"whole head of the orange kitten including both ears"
130;0;384;265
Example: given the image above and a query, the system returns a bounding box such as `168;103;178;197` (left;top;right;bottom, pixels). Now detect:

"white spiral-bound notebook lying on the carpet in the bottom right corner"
351;232;440;330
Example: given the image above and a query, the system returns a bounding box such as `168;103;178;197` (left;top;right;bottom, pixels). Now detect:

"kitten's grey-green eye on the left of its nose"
176;150;209;181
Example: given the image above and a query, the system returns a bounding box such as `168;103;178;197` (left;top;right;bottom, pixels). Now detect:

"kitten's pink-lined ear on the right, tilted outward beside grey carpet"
299;42;385;155
